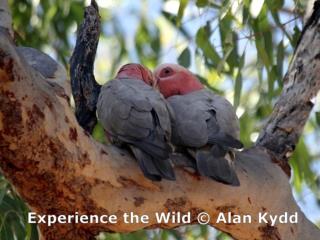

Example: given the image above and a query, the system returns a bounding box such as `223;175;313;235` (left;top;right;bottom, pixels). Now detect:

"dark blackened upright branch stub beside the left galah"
70;0;101;133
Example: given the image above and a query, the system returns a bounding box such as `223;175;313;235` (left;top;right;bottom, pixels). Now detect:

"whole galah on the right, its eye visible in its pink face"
154;64;243;186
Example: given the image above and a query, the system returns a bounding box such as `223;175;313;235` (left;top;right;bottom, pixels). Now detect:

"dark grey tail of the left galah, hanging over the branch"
130;146;176;181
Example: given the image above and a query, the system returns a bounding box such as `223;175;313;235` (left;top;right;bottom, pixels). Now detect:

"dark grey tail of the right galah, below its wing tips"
196;150;240;186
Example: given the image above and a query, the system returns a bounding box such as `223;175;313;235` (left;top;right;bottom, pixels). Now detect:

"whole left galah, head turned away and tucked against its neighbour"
97;64;175;181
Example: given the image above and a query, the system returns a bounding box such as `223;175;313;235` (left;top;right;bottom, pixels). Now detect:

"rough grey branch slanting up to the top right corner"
256;1;320;172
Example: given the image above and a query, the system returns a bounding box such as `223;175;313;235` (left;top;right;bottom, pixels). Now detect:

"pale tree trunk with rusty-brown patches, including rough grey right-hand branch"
0;1;320;240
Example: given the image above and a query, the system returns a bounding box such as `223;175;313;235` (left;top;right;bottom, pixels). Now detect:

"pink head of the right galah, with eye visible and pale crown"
153;64;203;98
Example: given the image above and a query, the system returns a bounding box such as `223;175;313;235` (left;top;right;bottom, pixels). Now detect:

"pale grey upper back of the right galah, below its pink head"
167;89;240;147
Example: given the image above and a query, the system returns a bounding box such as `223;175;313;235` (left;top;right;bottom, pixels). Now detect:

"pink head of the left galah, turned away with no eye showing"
116;63;154;86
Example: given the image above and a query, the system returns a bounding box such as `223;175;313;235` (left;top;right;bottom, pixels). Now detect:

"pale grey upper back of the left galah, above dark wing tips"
97;79;171;138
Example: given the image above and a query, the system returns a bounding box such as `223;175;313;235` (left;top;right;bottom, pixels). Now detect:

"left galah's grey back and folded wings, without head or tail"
97;79;171;159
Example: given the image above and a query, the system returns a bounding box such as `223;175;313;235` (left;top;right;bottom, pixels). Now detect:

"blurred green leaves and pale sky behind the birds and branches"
0;0;320;240
